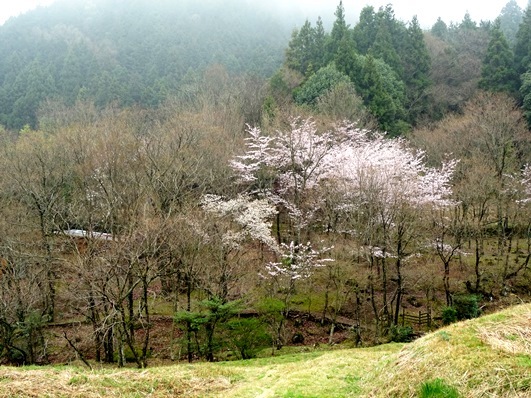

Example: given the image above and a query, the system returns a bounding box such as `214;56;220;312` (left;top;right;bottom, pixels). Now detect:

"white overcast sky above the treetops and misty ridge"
0;0;528;28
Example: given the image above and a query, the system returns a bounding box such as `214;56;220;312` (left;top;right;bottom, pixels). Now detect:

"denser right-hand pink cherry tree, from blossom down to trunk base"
328;130;456;323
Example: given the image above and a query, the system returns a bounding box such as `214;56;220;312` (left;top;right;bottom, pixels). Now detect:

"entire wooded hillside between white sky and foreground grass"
0;0;531;367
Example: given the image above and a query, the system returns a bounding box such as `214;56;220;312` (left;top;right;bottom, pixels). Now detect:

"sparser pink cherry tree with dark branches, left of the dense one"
231;119;333;238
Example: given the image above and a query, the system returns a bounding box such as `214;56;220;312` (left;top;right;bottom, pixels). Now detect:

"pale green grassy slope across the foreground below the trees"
0;305;531;398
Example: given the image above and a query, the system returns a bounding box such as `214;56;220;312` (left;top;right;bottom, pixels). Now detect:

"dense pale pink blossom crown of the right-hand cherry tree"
326;129;456;210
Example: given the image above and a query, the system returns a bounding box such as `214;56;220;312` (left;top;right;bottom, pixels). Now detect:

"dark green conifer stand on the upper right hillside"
285;1;531;135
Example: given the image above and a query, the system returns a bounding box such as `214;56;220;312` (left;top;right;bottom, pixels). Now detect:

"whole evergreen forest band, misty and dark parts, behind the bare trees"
0;0;530;135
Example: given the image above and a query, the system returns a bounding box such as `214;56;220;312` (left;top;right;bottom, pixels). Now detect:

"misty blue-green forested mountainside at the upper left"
0;0;291;129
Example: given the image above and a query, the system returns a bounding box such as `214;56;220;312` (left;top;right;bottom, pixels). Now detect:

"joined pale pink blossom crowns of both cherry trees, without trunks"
232;119;456;216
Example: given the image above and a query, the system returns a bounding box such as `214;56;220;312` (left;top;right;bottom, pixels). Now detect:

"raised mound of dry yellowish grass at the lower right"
366;305;531;398
